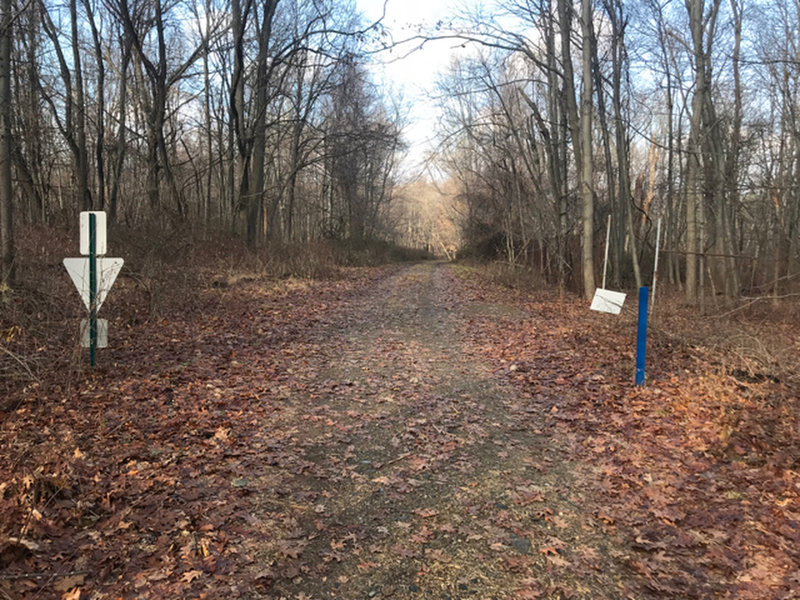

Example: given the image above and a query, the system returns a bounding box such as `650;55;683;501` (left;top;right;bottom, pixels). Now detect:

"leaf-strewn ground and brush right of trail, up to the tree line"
458;266;800;599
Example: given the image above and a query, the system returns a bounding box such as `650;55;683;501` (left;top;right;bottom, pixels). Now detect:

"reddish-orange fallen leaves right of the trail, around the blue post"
462;270;800;598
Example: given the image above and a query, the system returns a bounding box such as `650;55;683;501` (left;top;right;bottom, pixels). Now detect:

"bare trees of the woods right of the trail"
432;0;800;303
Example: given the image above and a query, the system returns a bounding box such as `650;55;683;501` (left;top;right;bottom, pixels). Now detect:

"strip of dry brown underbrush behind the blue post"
457;263;800;469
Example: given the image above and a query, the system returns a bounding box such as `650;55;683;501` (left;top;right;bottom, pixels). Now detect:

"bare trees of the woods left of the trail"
2;0;412;262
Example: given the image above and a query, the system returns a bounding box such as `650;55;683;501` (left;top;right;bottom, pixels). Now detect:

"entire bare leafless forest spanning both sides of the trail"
0;0;800;303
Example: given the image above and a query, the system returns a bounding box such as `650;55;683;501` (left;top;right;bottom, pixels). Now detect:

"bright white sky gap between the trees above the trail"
357;0;463;174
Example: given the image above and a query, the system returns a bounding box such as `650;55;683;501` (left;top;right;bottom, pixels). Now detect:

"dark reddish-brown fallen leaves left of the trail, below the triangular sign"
0;274;374;599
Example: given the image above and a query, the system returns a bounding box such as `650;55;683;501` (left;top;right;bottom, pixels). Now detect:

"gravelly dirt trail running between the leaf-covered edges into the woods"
252;264;630;599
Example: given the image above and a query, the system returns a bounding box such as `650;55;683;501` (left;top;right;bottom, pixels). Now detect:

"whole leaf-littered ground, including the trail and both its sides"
0;266;800;600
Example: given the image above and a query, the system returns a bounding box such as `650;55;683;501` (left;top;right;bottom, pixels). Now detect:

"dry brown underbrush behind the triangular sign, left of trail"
0;227;427;404
